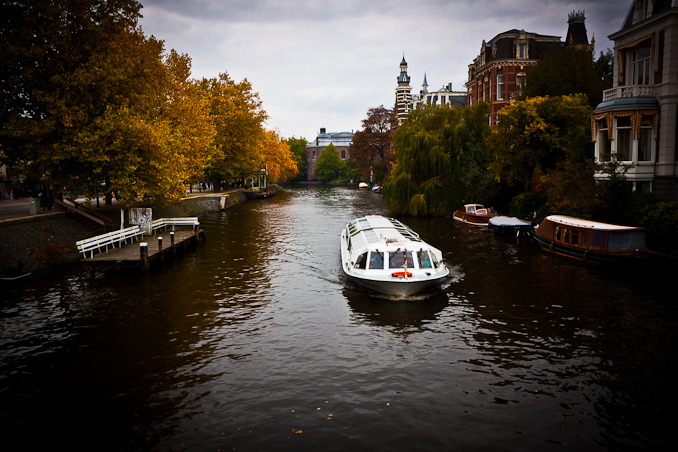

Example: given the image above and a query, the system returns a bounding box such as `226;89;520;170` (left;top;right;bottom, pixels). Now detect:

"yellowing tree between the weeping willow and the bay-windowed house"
488;96;595;213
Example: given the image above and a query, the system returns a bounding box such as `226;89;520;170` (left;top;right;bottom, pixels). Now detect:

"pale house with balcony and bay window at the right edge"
592;0;678;201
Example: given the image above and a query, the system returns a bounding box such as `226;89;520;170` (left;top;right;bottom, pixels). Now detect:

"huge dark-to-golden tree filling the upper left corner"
0;0;218;204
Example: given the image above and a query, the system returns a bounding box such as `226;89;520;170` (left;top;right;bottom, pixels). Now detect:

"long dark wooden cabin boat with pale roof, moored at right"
532;215;647;263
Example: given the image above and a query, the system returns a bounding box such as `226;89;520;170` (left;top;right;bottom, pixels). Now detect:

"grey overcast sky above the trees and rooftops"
139;0;631;141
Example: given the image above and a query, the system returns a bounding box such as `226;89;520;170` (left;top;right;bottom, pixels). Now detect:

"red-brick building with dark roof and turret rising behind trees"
466;12;594;127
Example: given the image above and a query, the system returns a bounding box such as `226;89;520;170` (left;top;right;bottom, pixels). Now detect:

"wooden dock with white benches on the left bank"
77;218;205;270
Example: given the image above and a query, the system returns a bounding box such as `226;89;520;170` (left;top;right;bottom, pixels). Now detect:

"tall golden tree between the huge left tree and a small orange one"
200;73;268;185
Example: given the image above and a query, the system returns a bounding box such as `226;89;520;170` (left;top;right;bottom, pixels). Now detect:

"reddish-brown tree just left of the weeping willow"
351;105;398;180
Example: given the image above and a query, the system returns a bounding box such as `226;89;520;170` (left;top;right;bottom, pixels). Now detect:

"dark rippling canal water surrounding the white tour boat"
0;187;678;451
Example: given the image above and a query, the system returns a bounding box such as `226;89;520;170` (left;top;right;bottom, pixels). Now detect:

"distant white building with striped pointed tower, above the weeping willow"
395;56;466;124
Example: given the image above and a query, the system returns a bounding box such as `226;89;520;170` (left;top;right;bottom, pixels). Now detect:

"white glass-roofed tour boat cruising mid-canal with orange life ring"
341;215;449;297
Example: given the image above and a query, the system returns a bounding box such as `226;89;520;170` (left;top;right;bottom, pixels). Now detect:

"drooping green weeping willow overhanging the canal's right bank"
382;104;493;216
